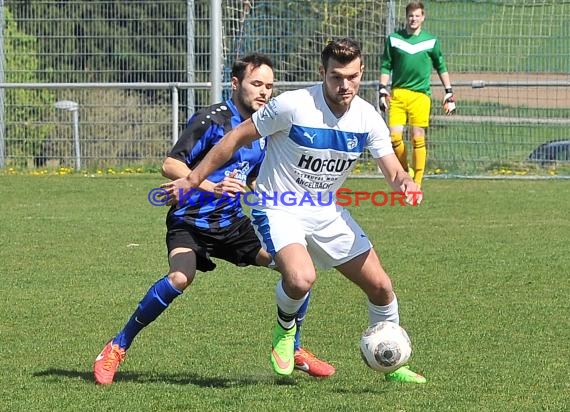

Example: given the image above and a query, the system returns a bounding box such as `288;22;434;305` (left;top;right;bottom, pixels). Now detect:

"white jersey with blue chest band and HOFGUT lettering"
252;84;393;210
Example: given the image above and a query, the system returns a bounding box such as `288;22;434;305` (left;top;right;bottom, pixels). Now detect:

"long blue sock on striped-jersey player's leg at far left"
113;276;182;349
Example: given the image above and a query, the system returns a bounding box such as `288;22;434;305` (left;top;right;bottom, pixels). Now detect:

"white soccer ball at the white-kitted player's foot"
360;321;412;373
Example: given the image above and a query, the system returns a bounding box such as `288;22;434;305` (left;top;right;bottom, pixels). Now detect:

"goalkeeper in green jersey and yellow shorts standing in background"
379;1;455;186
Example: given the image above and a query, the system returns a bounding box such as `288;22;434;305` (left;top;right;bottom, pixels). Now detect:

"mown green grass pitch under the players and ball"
0;175;570;411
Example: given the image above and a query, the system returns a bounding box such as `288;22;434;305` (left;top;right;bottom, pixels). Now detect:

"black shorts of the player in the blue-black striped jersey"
166;216;261;272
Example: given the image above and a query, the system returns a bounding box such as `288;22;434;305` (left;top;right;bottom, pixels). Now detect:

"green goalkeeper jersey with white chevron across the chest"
380;29;447;96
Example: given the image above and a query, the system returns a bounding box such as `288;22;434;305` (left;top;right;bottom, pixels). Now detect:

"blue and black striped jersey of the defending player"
167;99;265;230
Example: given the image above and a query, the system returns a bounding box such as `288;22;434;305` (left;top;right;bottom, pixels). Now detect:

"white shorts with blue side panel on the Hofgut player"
251;207;372;269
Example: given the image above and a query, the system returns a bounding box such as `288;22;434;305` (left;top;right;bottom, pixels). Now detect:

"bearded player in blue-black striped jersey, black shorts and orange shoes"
93;53;335;385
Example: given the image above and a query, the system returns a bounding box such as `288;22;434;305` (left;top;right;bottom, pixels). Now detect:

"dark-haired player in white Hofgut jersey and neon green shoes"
162;38;426;383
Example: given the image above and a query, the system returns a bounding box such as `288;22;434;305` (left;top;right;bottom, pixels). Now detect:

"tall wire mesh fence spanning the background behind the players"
0;0;570;174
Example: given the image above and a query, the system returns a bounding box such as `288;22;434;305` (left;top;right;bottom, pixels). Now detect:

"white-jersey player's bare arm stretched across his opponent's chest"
161;119;261;204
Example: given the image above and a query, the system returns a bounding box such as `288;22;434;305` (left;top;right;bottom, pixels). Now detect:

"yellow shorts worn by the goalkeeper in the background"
388;89;431;128
